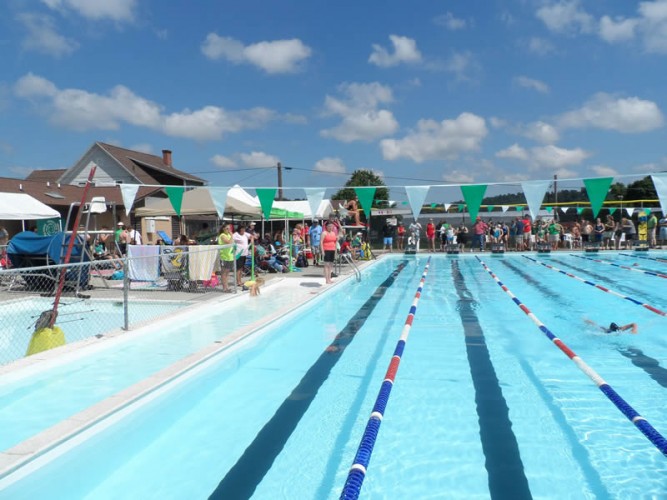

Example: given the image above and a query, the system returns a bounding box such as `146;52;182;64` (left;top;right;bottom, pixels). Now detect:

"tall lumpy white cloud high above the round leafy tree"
320;82;398;142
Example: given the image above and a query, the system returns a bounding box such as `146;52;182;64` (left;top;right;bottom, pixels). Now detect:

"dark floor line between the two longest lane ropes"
451;260;532;500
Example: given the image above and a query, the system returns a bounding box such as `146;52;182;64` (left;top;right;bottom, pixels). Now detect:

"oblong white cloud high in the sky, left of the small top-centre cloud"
201;33;312;74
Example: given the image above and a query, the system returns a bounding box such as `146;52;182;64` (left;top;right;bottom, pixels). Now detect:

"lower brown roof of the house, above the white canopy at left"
0;177;161;207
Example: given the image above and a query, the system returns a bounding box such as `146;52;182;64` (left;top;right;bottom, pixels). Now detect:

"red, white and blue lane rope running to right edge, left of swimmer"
475;256;667;457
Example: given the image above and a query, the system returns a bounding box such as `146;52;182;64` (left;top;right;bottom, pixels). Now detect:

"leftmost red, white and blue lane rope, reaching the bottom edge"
340;257;431;500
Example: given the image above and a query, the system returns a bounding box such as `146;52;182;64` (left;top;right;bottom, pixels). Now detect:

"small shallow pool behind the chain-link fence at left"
0;297;188;363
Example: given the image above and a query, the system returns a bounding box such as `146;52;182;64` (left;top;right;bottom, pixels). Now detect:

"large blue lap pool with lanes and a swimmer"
0;253;667;498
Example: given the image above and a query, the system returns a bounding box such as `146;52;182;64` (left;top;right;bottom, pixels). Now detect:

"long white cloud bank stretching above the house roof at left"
14;73;279;141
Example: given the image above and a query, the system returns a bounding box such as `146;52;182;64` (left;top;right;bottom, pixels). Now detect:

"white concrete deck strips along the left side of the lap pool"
0;256;382;480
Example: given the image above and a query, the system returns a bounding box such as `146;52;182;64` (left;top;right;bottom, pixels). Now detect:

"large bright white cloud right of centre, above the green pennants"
380;113;488;163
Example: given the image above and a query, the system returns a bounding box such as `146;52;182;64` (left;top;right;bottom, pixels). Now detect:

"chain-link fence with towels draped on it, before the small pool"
0;245;240;365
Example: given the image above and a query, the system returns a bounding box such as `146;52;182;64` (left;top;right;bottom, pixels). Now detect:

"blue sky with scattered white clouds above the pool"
0;0;667;197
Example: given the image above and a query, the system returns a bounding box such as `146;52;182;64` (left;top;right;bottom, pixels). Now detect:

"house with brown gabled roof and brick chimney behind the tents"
0;142;206;241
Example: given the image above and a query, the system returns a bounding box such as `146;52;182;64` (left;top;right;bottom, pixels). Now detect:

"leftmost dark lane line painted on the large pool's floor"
209;260;408;500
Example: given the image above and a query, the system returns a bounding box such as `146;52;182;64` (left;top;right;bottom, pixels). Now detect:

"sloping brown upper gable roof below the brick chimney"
96;142;206;185
